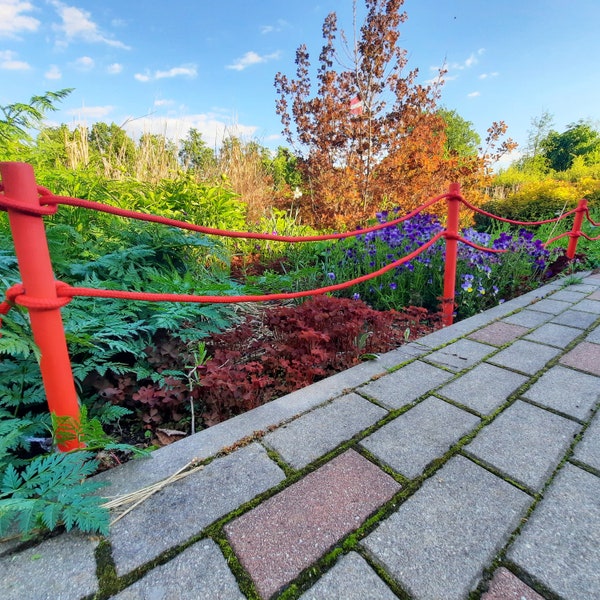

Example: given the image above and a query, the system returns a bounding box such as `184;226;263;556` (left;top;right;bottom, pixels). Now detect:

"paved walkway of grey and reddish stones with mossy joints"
0;274;600;600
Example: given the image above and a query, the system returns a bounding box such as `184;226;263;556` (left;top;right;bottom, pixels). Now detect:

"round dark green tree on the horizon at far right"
541;120;600;171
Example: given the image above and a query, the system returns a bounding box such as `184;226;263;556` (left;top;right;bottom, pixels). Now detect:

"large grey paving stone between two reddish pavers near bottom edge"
361;456;532;600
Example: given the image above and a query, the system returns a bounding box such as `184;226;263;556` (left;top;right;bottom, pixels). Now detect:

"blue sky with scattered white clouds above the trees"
0;0;600;166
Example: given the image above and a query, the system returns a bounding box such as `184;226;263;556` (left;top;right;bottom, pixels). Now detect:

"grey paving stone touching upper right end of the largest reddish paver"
360;396;480;479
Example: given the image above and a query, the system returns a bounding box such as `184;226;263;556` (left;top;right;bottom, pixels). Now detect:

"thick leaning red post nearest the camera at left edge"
0;163;82;451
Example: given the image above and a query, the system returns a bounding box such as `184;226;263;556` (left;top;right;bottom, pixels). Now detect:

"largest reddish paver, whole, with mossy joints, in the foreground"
225;450;400;598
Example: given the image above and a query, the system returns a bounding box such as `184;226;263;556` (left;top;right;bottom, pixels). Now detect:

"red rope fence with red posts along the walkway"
0;163;600;450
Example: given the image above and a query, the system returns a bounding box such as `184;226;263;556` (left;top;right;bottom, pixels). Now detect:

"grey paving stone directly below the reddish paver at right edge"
523;365;600;421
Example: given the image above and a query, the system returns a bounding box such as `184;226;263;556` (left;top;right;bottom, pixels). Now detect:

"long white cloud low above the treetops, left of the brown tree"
123;113;258;148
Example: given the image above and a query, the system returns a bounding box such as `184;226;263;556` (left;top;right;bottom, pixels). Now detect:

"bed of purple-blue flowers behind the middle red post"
323;210;551;317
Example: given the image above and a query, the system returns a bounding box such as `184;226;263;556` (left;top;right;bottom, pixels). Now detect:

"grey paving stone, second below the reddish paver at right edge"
463;400;581;492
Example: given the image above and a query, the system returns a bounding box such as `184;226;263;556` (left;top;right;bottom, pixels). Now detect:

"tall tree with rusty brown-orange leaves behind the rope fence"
275;0;514;228
